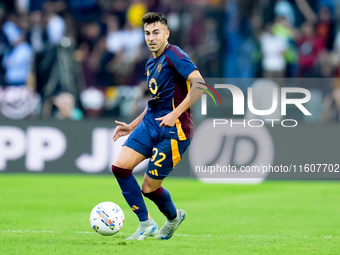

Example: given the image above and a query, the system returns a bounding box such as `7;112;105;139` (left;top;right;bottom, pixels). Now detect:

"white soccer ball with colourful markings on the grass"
90;202;124;236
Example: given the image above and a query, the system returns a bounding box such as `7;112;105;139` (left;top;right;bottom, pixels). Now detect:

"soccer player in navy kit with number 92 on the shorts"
112;12;205;240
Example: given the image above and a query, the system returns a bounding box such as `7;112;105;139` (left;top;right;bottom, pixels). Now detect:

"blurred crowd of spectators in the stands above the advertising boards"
0;0;340;122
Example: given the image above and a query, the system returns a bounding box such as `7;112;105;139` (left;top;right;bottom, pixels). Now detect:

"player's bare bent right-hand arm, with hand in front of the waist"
156;70;206;127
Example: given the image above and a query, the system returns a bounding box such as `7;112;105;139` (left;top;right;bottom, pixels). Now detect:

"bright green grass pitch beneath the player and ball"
0;174;340;255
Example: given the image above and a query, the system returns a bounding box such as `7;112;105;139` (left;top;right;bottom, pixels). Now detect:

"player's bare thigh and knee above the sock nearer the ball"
114;146;146;170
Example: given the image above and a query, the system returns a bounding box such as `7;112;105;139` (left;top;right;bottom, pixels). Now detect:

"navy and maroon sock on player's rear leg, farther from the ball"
142;186;177;220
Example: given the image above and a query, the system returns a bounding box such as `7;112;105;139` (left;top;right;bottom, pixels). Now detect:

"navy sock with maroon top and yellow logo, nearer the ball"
111;165;149;221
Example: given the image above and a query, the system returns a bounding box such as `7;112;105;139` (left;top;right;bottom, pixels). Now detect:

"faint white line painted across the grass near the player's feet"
1;229;340;239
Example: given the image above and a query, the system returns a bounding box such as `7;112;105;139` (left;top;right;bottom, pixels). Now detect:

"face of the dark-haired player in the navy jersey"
144;22;170;57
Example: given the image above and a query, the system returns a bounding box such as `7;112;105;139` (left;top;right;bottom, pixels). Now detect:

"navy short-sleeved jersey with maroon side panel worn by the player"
143;44;197;141
